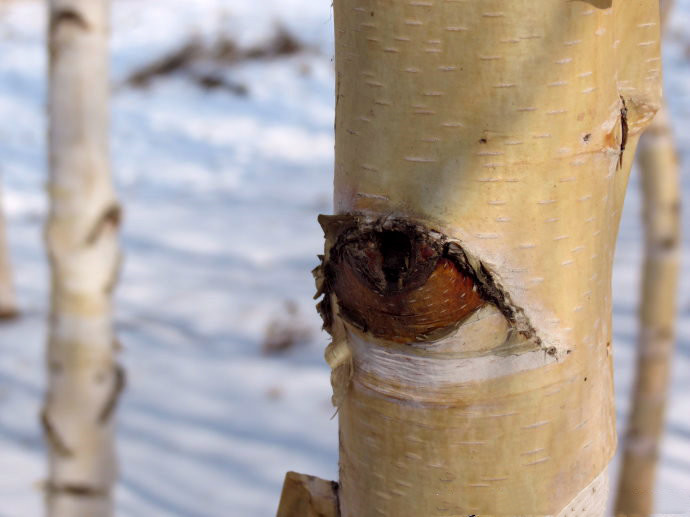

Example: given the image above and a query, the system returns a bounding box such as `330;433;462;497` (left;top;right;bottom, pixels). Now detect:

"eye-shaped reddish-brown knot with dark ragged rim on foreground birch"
315;214;539;343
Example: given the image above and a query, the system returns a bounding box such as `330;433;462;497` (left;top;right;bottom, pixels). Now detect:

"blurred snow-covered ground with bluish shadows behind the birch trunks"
0;0;690;517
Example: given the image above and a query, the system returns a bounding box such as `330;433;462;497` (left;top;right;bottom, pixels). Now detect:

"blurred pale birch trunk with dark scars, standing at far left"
41;0;124;517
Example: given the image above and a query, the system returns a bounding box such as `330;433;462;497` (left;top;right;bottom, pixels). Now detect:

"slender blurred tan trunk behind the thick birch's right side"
616;103;680;515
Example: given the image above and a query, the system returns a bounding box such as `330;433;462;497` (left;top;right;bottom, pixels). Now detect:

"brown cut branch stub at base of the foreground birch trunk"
276;472;340;517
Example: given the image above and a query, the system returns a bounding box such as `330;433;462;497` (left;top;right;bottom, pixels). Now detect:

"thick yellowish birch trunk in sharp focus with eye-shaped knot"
280;0;660;517
